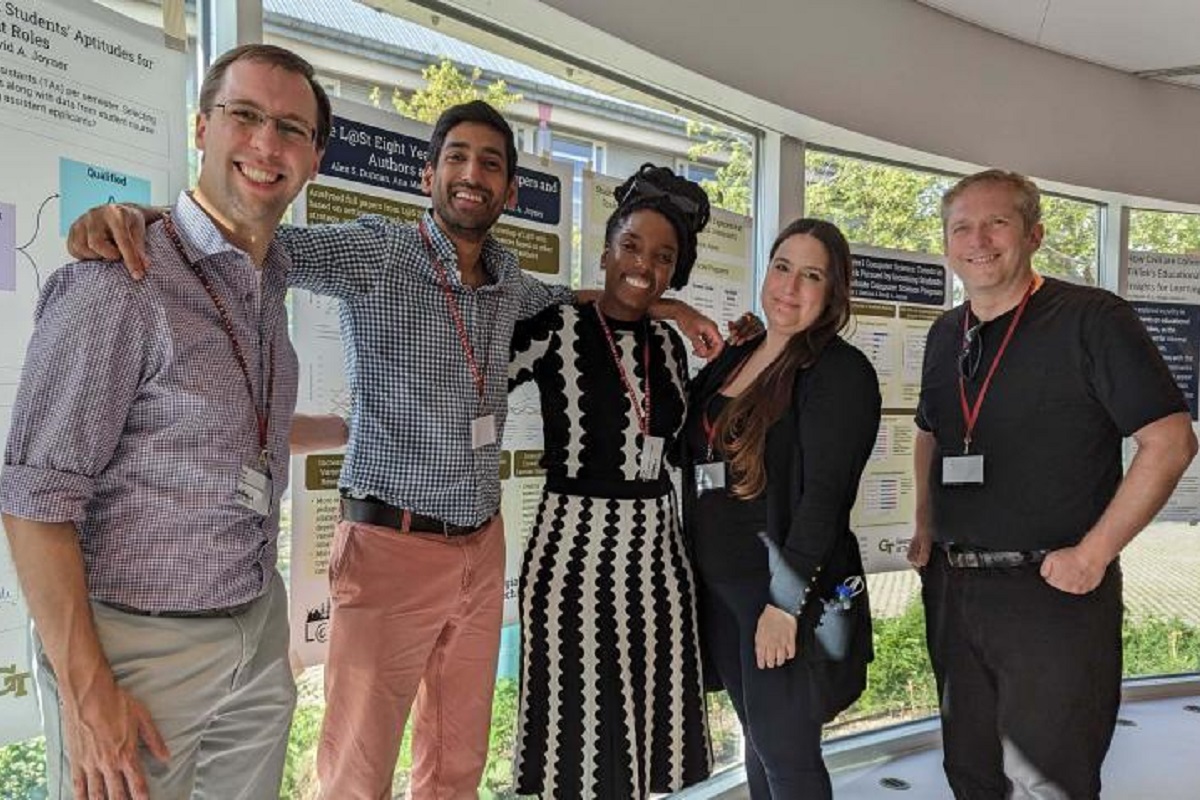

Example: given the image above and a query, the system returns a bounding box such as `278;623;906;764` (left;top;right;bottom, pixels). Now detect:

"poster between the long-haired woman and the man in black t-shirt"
845;247;949;572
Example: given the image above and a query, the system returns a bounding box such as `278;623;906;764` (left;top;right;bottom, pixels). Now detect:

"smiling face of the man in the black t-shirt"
946;182;1043;299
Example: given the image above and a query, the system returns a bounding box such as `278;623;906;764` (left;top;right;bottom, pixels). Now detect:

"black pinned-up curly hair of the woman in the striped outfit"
604;163;709;289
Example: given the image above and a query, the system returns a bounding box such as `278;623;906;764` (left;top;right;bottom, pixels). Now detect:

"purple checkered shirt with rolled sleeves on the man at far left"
0;193;298;612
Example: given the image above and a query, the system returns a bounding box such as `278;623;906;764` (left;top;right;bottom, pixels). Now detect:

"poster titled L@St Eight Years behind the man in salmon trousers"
290;101;571;666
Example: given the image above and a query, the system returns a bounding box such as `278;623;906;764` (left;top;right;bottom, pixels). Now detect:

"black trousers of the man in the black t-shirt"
922;547;1123;800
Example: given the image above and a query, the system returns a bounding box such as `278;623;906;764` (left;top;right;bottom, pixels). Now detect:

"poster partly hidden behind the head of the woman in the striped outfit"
580;173;757;371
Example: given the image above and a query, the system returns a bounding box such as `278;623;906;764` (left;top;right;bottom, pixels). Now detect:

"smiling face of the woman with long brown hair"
761;234;830;336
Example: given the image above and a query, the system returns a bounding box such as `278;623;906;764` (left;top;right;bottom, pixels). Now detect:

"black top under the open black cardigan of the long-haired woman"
683;391;767;582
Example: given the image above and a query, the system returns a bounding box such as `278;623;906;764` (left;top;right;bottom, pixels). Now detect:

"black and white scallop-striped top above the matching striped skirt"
509;303;688;498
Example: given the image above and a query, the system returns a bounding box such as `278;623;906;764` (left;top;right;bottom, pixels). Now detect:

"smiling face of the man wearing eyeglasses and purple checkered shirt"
196;60;322;245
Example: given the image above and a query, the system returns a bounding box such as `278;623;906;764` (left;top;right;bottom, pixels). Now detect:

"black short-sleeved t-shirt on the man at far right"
917;278;1188;551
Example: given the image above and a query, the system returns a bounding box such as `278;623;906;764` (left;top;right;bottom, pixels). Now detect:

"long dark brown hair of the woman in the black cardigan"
716;218;853;499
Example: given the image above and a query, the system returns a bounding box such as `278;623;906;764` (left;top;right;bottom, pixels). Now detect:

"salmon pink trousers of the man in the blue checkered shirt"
317;515;504;800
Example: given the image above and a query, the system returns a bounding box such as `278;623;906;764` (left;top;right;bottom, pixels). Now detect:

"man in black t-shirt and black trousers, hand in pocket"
908;170;1196;800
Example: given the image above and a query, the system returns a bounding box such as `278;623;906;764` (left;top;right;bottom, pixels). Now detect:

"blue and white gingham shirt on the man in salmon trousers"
278;212;572;525
